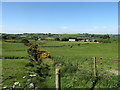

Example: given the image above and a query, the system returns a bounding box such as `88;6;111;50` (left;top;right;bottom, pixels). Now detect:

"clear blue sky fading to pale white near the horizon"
2;2;118;34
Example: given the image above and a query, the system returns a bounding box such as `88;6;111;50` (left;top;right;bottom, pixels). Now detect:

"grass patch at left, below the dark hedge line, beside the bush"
1;59;28;86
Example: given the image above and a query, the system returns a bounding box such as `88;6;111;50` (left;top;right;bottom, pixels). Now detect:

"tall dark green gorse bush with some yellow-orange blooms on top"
22;42;50;89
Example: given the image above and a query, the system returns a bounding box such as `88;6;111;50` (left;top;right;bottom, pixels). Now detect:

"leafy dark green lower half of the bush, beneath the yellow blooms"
24;60;50;88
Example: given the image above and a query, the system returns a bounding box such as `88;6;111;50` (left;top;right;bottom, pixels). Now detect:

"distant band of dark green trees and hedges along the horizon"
0;33;118;43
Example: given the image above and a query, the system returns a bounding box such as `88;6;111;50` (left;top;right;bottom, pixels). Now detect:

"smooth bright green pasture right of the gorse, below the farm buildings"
38;42;118;59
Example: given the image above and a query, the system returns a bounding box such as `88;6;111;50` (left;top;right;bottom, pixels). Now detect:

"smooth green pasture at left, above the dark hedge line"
2;42;27;57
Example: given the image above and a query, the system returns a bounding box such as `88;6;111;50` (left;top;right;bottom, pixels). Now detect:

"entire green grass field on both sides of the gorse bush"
2;41;118;88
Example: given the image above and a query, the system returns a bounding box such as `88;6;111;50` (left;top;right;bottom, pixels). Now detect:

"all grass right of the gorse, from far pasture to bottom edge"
38;42;118;88
